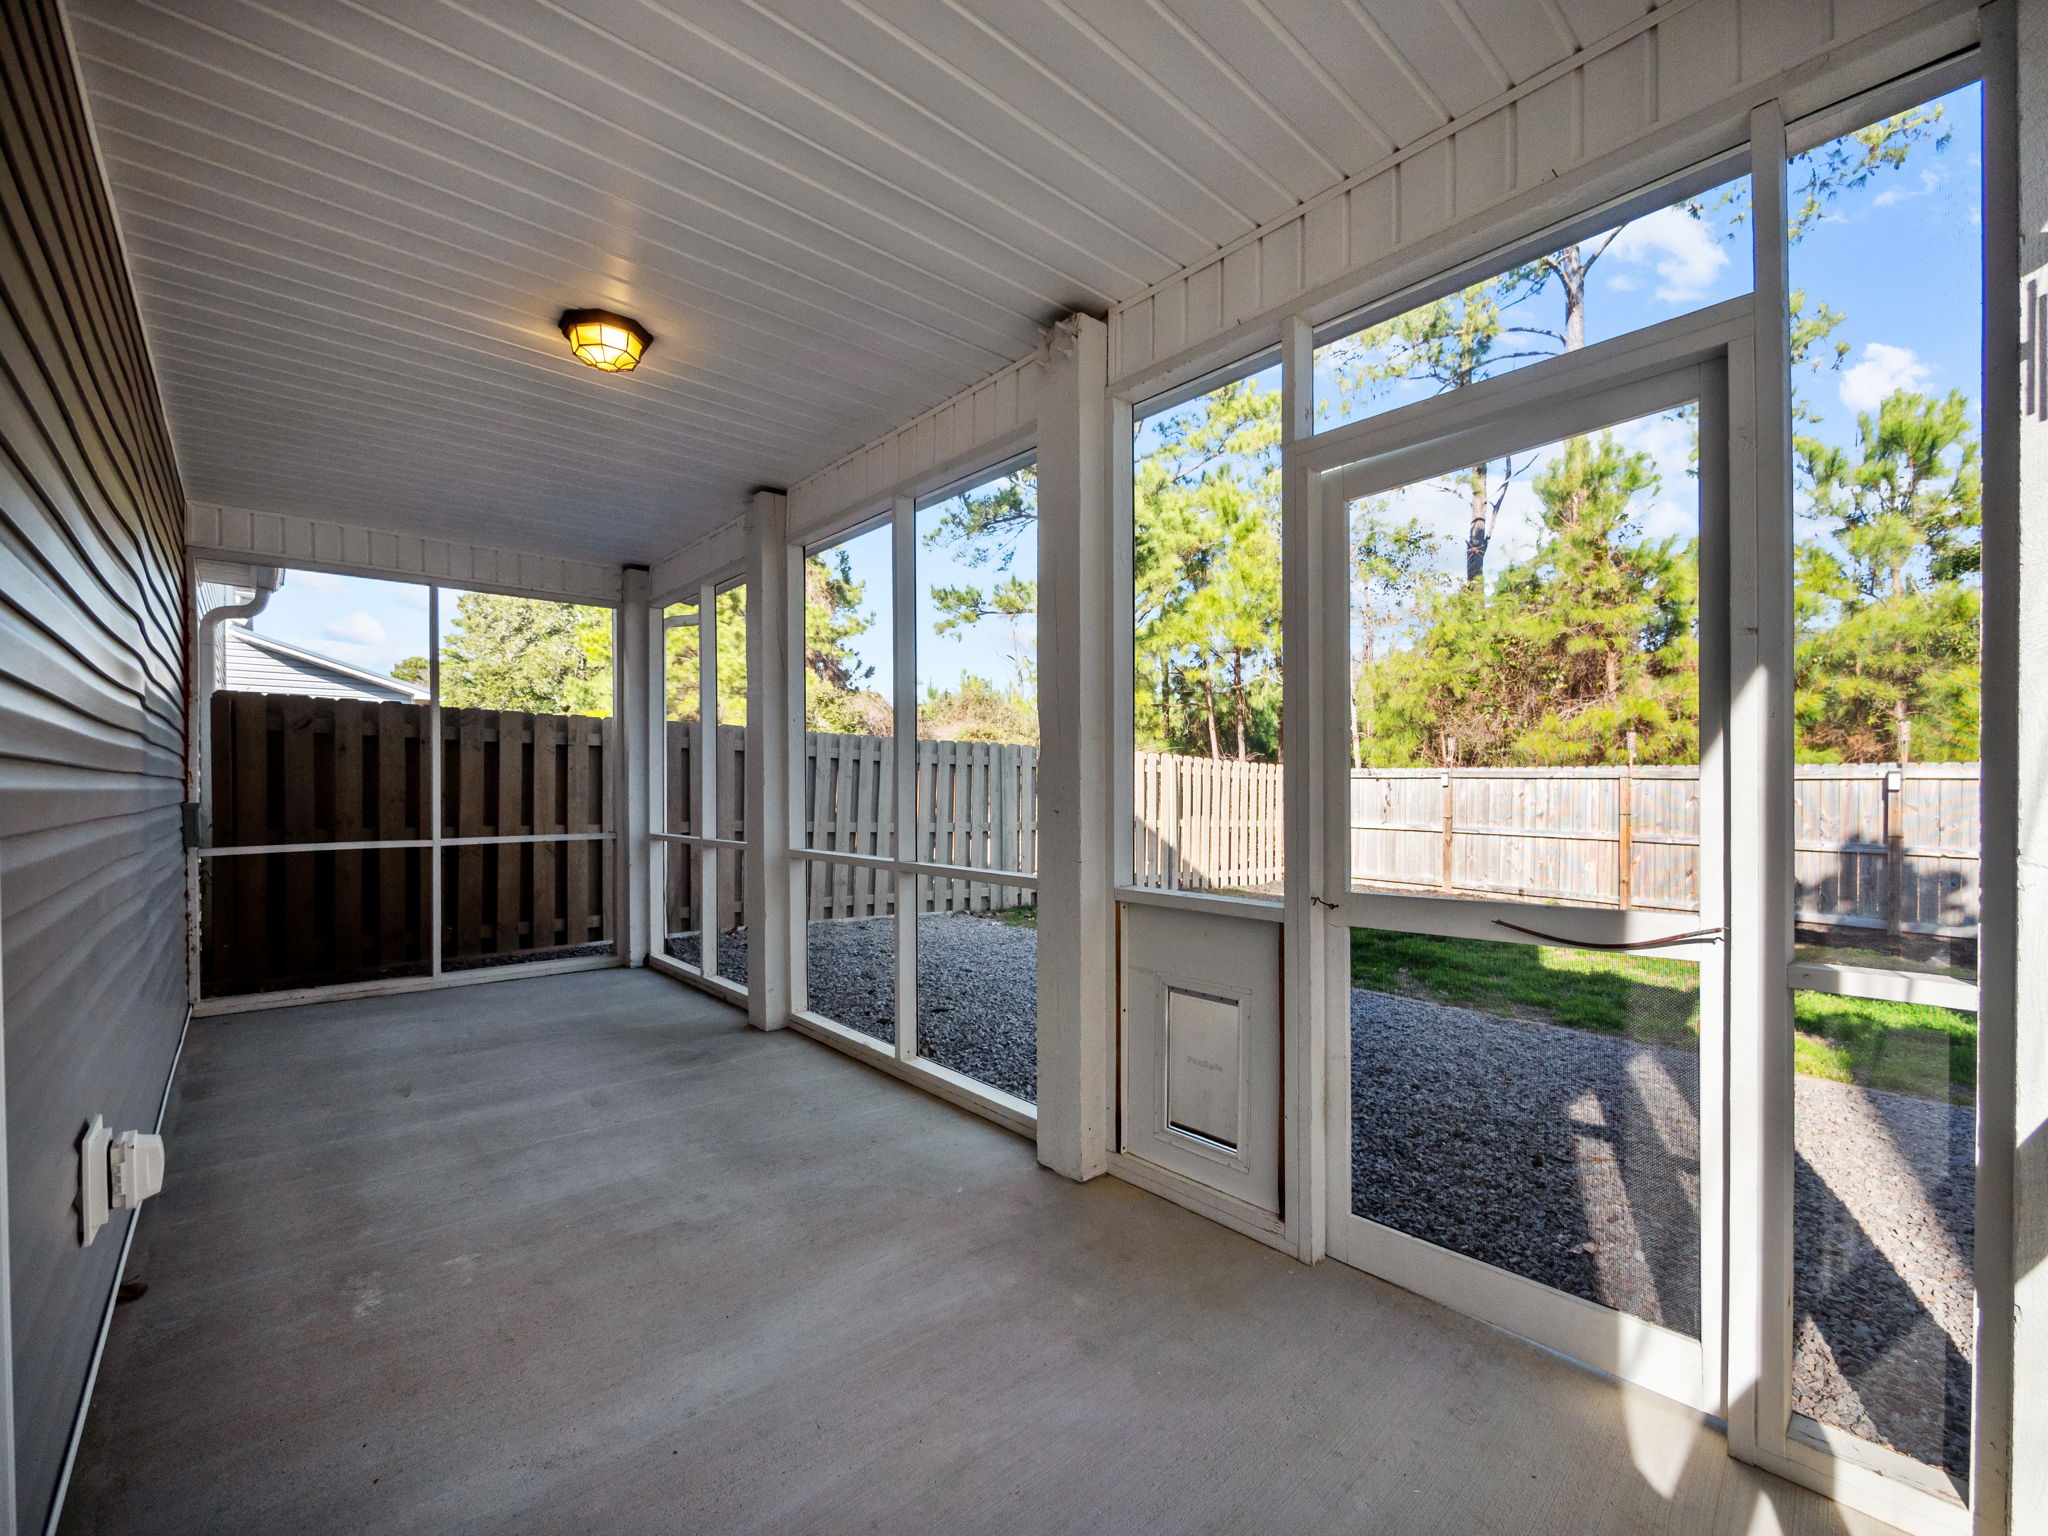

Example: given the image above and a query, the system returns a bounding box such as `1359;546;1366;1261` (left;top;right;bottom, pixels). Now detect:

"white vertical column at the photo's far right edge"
1970;0;2048;1536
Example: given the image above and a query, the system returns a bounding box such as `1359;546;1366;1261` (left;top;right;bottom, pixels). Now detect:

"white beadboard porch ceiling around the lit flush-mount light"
68;0;1649;561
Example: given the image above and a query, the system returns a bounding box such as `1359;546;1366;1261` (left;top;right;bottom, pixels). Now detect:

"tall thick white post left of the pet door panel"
1038;315;1120;1180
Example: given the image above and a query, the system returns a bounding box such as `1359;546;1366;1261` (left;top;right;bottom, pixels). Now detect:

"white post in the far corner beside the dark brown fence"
612;565;666;965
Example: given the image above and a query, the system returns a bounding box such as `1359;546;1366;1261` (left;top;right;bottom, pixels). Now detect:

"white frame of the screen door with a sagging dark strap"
1290;313;1751;1413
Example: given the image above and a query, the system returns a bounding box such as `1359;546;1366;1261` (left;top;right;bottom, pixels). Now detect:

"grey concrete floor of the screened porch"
63;971;1886;1536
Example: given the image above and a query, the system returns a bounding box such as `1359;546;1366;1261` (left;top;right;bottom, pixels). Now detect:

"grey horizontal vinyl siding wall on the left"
0;0;186;1532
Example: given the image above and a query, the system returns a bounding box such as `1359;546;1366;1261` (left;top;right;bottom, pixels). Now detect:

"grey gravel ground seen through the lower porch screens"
670;913;1974;1475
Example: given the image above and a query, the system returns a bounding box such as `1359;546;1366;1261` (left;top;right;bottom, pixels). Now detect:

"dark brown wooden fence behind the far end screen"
201;692;614;995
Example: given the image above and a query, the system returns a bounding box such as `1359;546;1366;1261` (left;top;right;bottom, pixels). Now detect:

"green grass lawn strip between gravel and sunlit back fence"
1352;928;1976;1104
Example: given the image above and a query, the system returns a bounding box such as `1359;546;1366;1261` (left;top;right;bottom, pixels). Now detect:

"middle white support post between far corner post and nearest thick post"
745;492;803;1030
